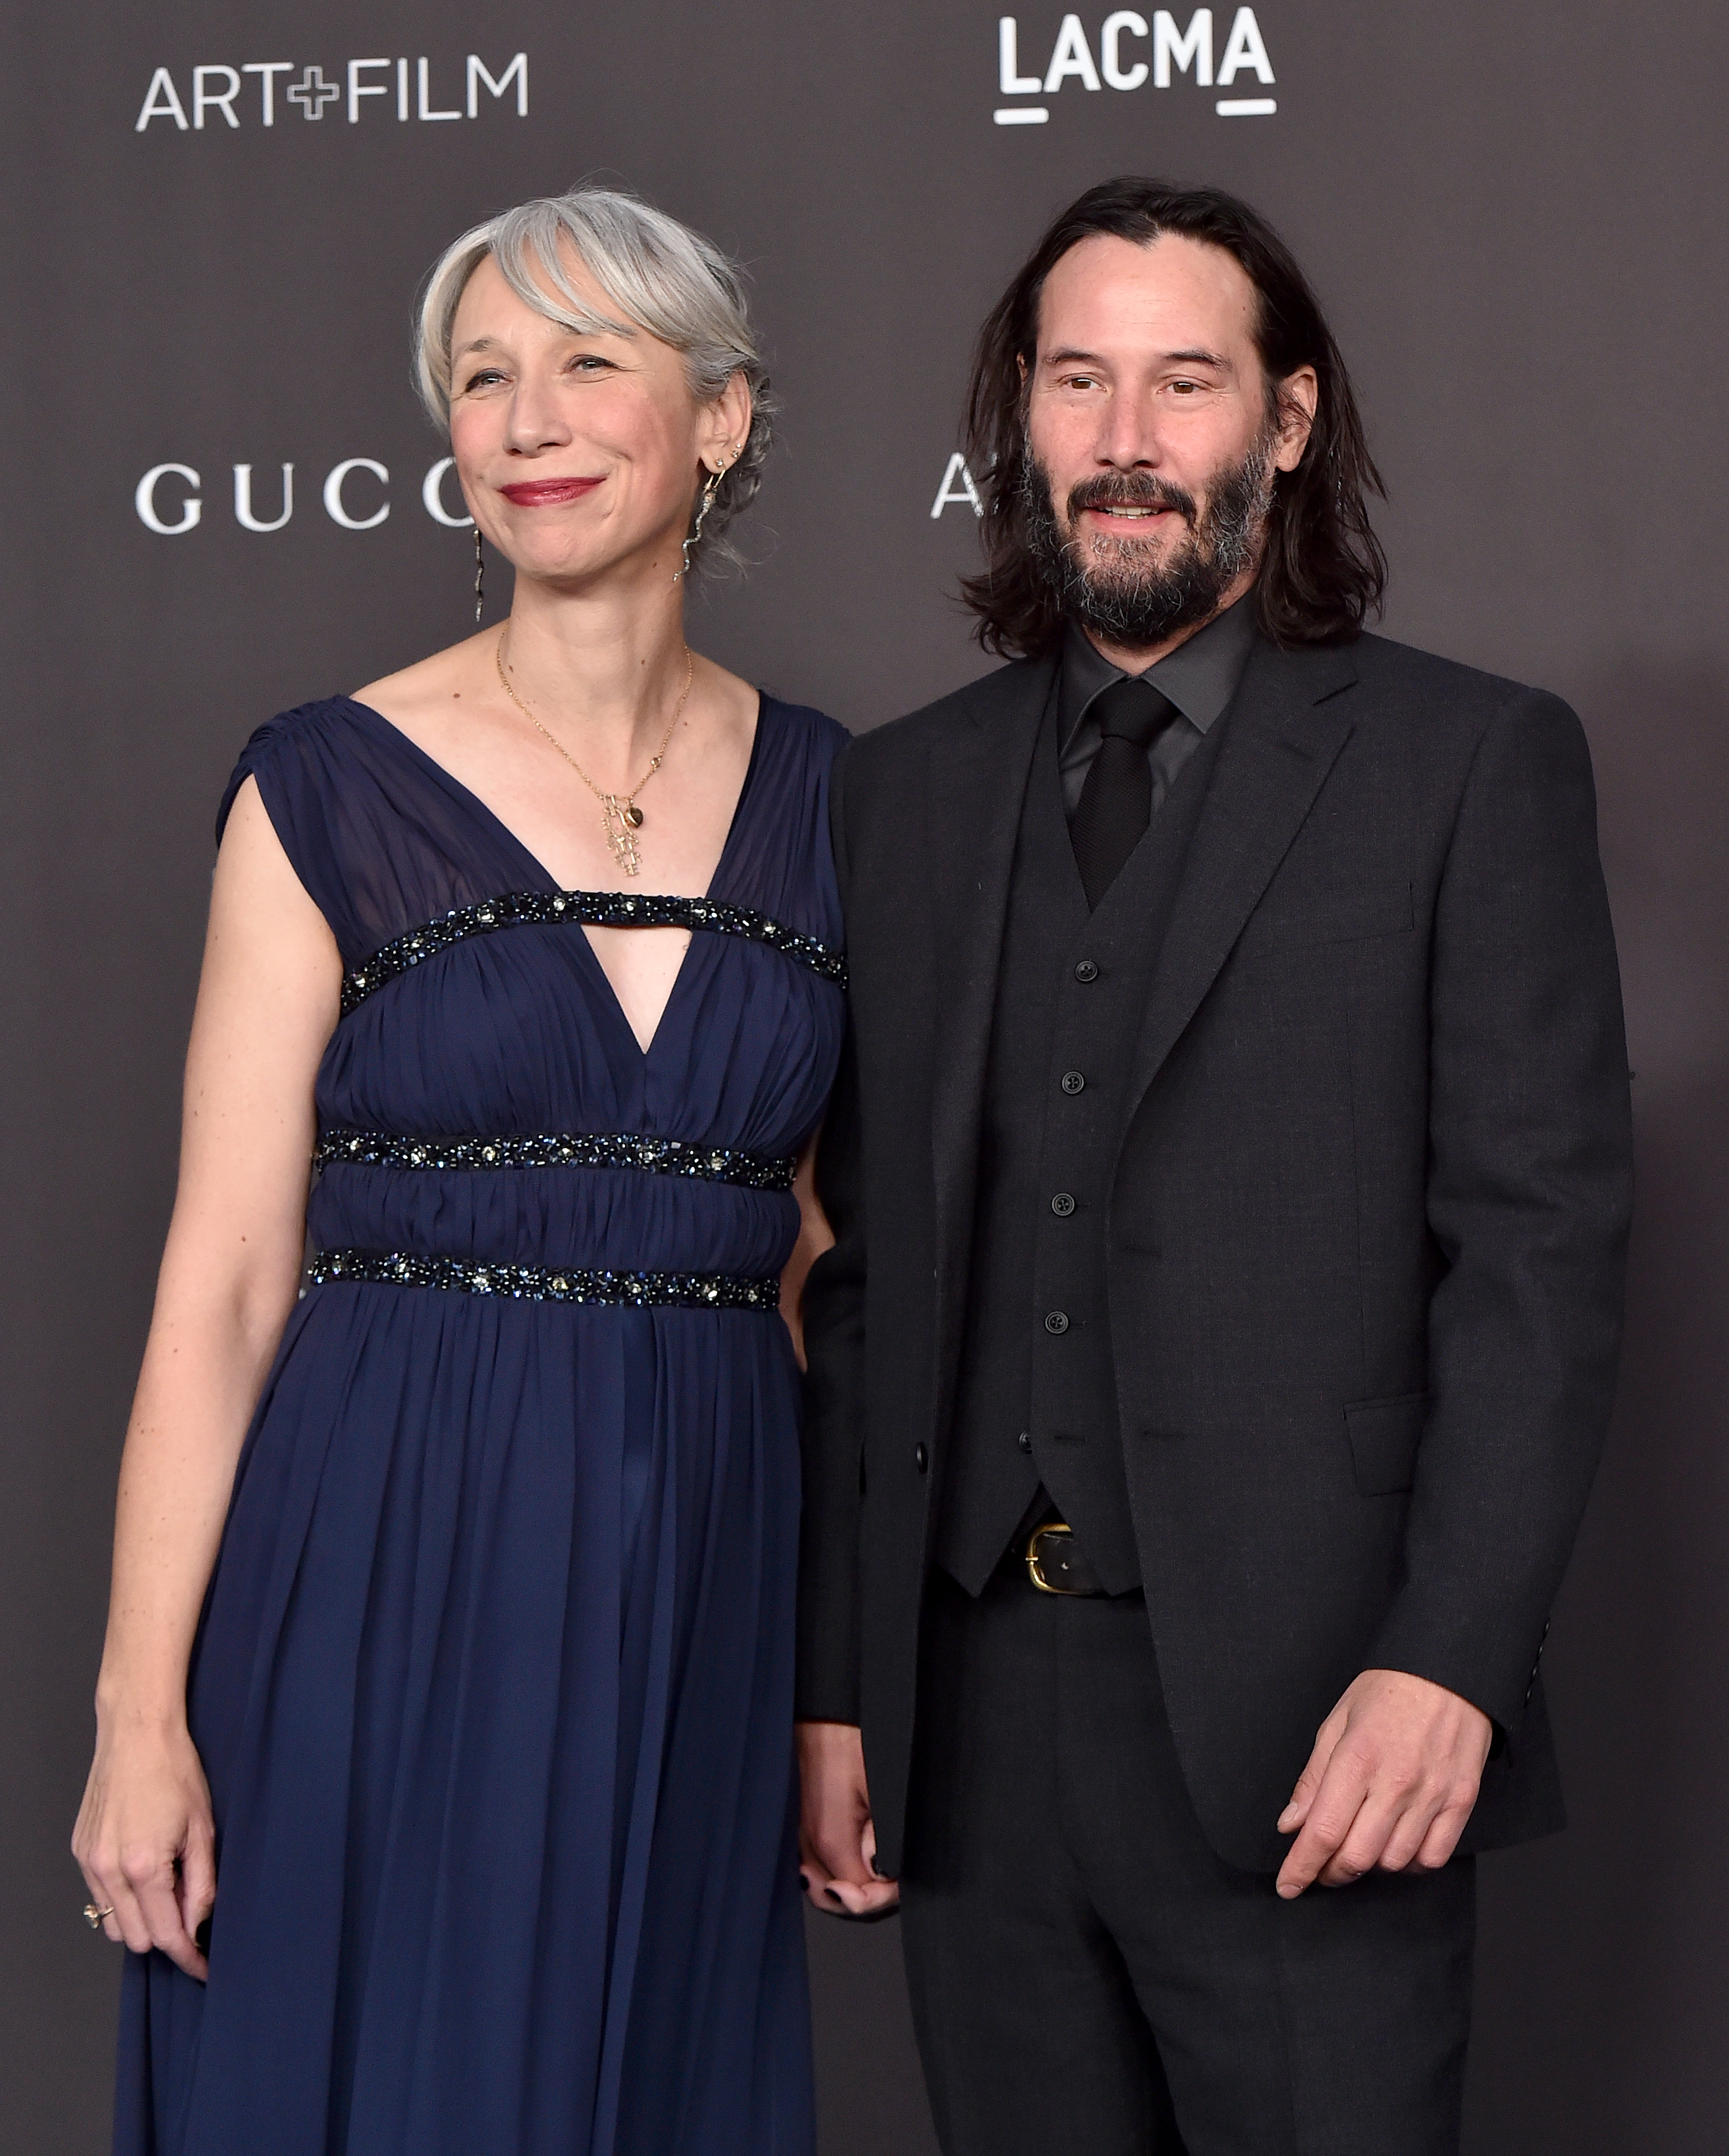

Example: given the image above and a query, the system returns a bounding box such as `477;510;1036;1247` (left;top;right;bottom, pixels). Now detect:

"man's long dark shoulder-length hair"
962;179;1386;658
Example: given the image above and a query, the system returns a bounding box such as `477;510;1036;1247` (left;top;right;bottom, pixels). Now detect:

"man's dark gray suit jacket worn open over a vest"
800;636;1630;1871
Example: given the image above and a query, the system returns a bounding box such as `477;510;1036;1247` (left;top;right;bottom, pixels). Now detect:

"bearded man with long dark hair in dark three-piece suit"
800;179;1630;2156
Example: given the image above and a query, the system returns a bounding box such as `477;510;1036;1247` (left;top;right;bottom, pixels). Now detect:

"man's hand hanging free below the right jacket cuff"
1279;1669;1494;1902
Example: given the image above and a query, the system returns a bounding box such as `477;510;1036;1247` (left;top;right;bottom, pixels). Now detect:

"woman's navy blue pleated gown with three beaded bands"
115;699;845;2156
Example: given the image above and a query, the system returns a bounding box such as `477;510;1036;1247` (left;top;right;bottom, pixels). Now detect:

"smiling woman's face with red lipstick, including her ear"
451;254;750;585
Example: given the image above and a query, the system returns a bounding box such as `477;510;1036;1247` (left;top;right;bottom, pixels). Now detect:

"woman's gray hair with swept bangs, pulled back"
414;188;774;569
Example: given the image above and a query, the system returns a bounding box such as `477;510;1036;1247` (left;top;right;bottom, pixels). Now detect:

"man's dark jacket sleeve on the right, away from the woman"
1369;692;1632;1732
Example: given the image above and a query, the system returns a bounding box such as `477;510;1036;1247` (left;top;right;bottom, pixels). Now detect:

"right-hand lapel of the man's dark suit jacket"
1123;645;1356;1128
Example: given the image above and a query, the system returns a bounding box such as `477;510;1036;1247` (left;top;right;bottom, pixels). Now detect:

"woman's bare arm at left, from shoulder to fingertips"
73;780;343;1977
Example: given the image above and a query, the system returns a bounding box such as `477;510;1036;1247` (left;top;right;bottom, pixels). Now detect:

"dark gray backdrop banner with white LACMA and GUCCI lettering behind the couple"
0;0;1729;2156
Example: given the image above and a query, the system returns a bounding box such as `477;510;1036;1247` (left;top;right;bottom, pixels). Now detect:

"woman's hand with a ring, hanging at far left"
71;1725;216;1982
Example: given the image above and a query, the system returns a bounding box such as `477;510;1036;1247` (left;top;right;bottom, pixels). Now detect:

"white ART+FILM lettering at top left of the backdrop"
132;52;528;134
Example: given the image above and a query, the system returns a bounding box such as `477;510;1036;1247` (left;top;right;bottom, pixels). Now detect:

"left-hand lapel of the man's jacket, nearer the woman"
927;662;1056;1412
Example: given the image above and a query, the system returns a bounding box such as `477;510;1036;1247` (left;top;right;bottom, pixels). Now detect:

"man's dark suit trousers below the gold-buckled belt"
901;1565;1475;2156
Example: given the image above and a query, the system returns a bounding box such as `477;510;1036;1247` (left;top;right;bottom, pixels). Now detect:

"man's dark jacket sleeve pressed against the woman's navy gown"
796;757;865;1723
